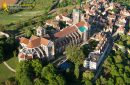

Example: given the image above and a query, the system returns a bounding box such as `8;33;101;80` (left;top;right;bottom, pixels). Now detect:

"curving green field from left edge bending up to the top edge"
0;0;53;25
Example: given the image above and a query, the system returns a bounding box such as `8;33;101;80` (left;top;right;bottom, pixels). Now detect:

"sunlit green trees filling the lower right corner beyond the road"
96;35;130;85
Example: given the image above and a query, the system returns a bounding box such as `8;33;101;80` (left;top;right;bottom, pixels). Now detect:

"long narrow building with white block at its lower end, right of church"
83;32;108;70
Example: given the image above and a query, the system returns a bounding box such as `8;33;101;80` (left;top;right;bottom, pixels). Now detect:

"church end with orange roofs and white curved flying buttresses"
18;35;55;61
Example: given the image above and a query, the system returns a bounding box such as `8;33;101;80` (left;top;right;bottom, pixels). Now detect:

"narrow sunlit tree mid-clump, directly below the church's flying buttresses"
31;59;42;76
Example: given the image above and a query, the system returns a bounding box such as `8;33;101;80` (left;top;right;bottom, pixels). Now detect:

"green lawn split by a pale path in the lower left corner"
0;57;18;82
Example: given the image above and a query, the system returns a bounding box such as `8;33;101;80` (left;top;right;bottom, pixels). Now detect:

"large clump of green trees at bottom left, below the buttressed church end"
16;60;66;85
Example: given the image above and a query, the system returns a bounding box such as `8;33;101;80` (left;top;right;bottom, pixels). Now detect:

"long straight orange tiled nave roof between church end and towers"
54;26;77;38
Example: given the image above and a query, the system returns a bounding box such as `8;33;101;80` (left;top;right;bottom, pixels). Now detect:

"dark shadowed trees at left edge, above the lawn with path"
0;36;18;63
